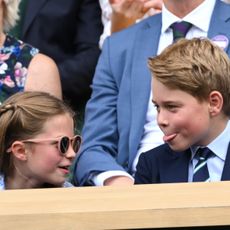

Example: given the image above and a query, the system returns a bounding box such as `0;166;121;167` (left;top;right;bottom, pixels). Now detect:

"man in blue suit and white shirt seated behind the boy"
75;0;230;185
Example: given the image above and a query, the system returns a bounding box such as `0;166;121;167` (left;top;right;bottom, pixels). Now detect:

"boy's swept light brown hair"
148;38;230;116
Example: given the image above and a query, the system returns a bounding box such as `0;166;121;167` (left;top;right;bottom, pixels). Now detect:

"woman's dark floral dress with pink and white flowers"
0;35;39;104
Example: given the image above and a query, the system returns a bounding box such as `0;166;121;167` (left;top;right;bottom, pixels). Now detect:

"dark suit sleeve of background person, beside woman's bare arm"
57;0;103;104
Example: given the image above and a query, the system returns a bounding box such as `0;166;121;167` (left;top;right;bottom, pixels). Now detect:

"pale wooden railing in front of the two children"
0;182;230;230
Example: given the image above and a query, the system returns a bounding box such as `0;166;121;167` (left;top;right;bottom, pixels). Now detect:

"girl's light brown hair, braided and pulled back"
0;92;74;175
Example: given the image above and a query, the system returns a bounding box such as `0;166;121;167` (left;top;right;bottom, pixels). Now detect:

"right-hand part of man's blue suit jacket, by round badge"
208;1;230;54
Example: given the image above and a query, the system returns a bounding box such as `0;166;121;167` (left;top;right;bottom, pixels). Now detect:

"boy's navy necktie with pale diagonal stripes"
193;147;213;182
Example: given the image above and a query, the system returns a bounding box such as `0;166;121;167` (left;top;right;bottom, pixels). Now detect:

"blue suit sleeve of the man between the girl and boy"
74;36;124;185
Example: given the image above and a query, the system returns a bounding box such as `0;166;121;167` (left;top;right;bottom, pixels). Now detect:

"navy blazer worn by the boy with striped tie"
135;144;230;184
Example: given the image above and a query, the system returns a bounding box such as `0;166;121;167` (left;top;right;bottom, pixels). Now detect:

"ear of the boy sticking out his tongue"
209;90;223;116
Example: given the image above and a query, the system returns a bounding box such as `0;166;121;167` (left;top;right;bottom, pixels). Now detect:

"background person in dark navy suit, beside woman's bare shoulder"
20;0;103;108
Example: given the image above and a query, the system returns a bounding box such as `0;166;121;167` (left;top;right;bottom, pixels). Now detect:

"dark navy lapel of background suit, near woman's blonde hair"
22;0;48;36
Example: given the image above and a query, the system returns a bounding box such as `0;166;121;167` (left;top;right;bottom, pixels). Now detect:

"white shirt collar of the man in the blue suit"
161;0;216;33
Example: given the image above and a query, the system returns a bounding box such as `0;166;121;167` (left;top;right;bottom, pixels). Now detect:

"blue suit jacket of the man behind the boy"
74;0;230;185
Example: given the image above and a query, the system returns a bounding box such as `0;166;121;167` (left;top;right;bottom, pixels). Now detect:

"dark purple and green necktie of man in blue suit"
170;21;192;42
